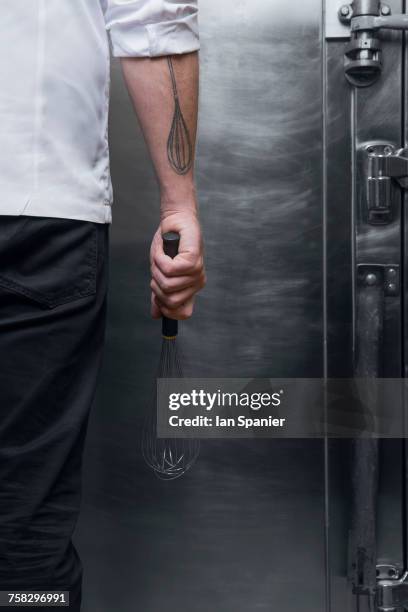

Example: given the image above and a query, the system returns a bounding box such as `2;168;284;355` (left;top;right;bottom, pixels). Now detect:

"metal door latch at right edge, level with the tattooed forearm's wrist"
365;143;408;225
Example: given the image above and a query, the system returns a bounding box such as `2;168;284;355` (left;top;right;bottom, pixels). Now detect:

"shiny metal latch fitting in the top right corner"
326;0;408;87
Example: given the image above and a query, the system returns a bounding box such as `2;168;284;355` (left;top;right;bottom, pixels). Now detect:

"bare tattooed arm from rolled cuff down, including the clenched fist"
122;53;205;319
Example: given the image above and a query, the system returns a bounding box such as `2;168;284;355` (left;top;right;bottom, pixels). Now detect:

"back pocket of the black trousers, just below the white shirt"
0;216;97;308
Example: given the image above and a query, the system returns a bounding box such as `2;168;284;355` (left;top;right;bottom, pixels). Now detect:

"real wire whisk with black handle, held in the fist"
142;232;200;480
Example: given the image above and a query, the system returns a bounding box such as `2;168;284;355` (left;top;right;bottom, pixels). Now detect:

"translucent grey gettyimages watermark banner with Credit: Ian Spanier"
157;378;408;438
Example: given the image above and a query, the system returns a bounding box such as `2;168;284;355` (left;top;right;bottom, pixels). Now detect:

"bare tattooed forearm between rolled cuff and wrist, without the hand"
122;53;198;217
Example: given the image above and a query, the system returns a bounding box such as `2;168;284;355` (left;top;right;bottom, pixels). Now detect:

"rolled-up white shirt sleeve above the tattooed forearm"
105;0;200;57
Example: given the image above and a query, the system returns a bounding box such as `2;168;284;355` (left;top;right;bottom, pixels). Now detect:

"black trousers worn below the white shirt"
0;216;109;612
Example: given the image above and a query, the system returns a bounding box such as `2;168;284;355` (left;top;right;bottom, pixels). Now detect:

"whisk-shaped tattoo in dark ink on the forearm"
167;57;193;174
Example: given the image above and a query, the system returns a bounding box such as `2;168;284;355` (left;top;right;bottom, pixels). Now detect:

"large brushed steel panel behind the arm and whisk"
78;0;325;612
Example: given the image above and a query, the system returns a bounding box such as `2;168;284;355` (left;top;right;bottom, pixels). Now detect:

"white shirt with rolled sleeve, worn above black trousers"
0;0;199;223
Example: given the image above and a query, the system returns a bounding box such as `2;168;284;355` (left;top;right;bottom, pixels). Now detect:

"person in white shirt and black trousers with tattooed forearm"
0;0;205;611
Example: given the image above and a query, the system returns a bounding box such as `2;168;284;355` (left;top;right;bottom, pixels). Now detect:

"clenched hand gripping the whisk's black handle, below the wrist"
150;211;206;320
